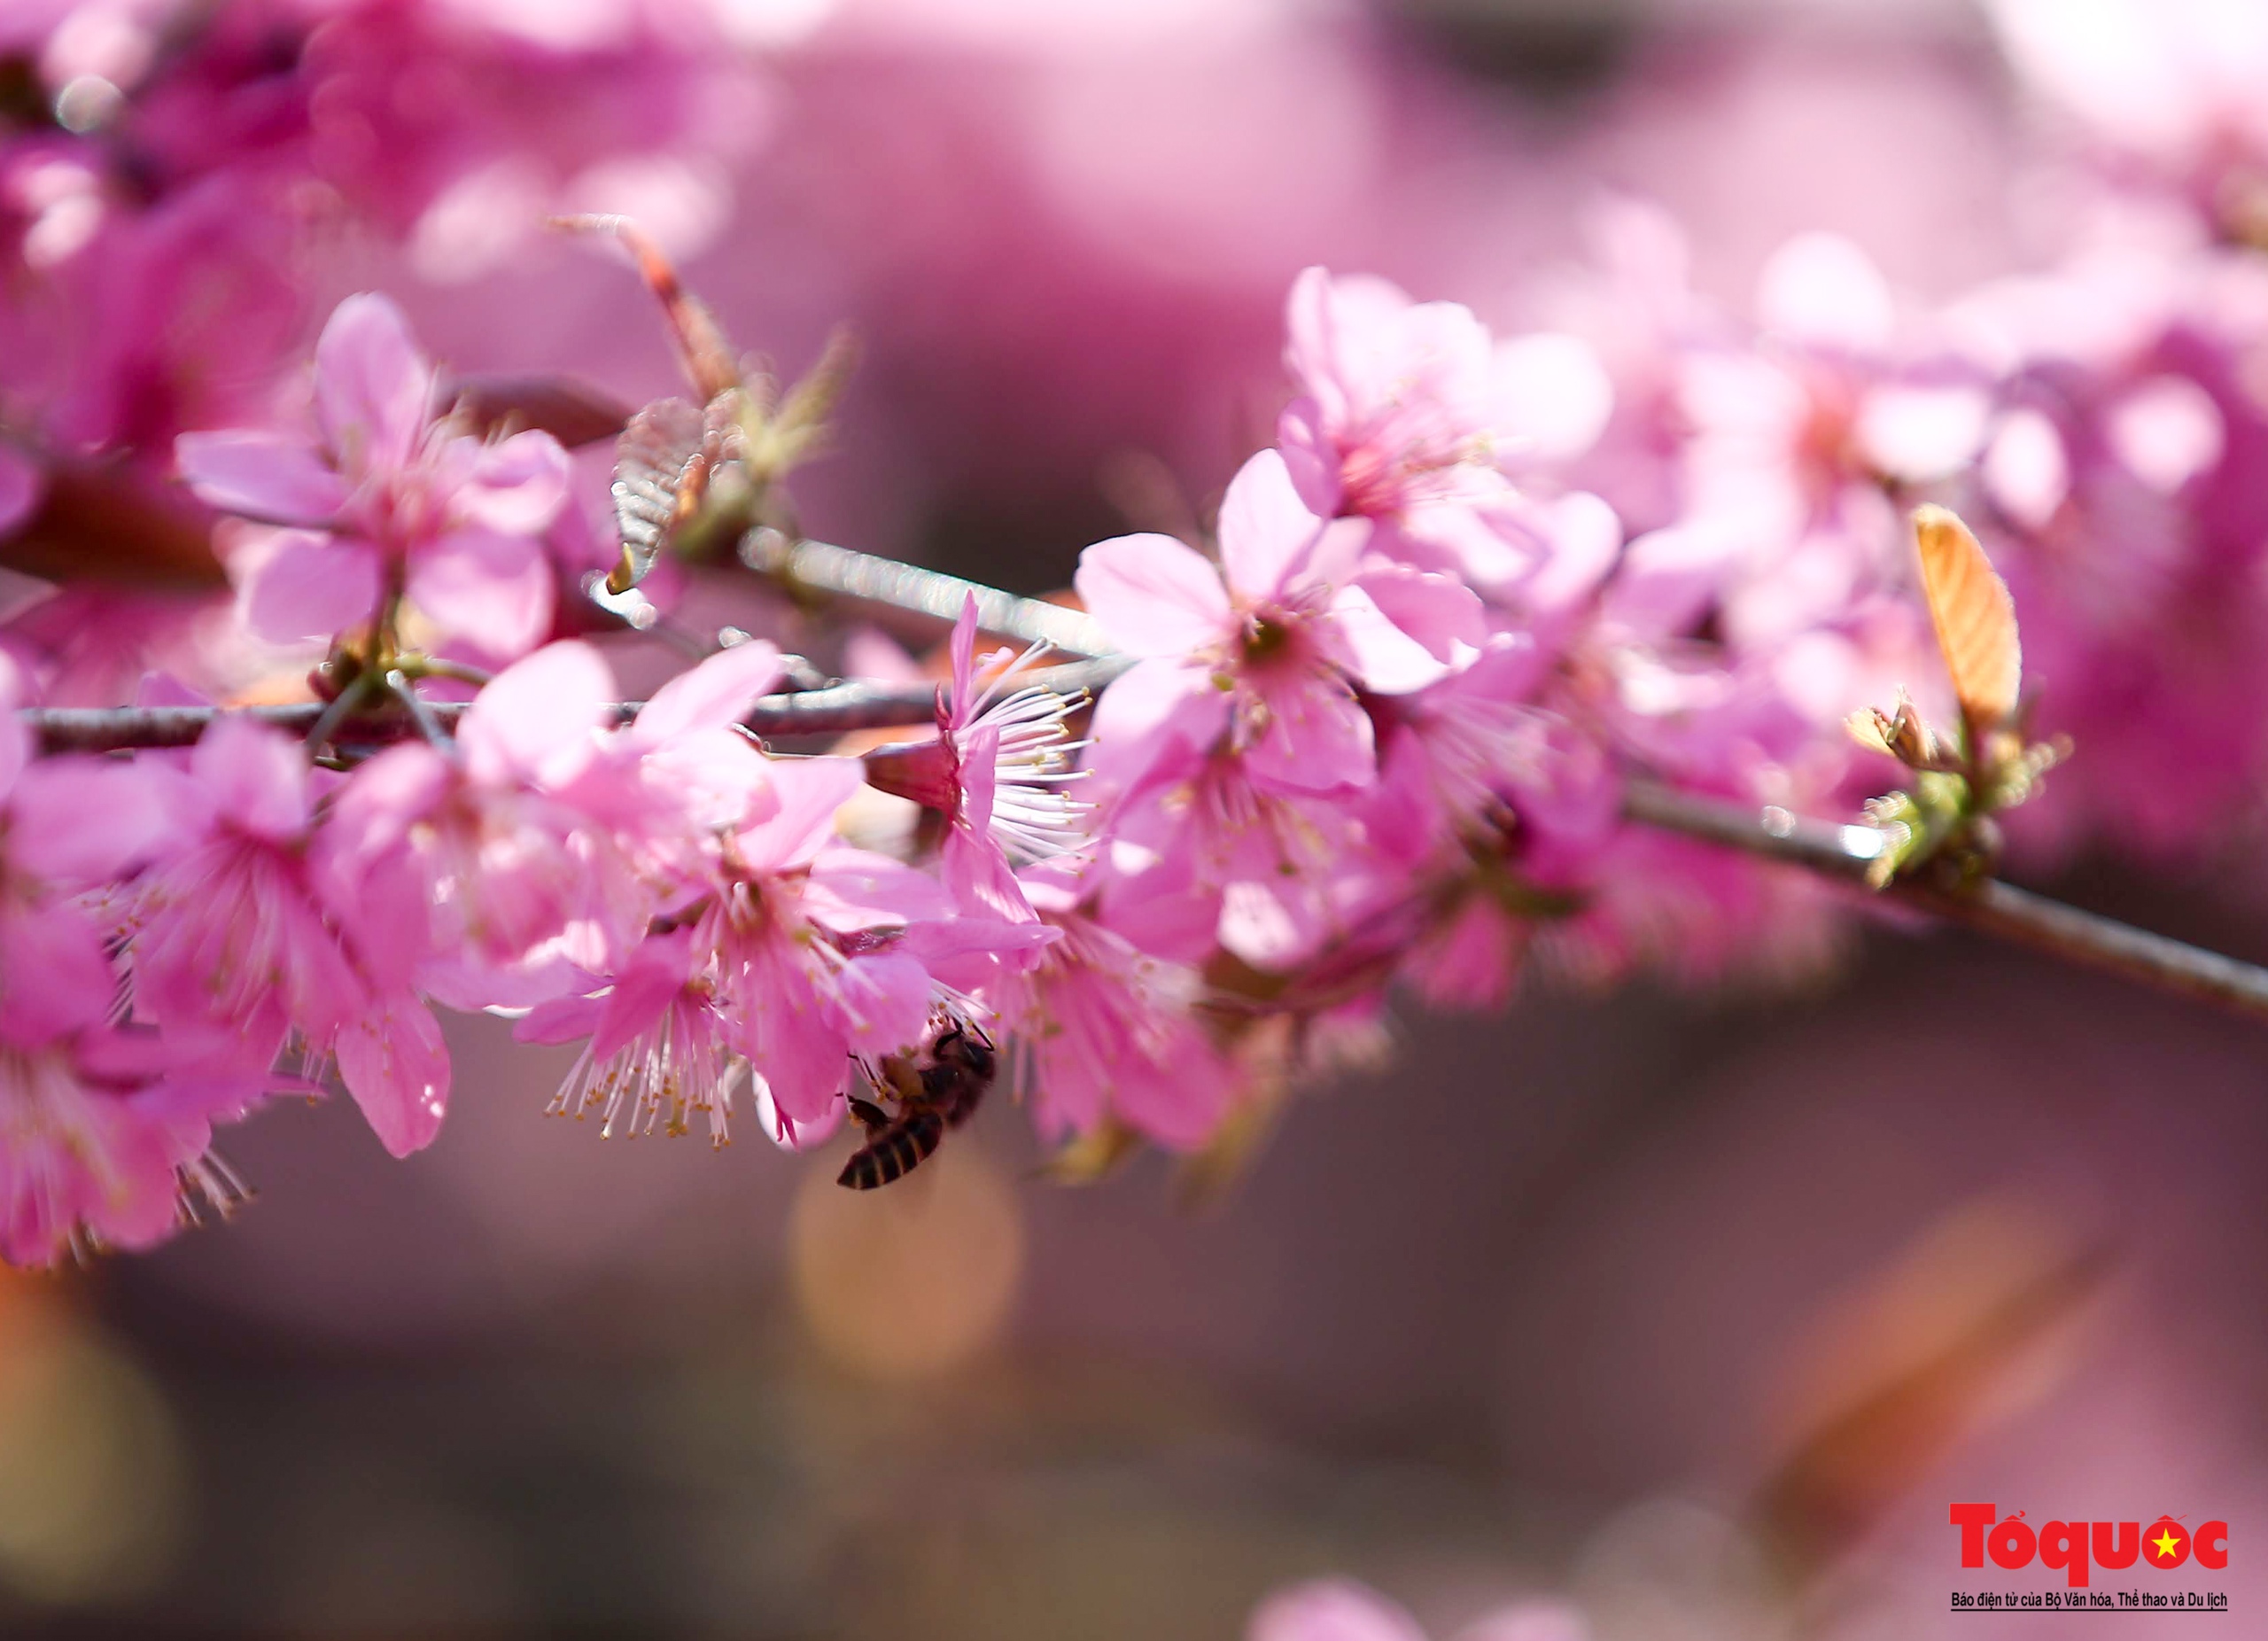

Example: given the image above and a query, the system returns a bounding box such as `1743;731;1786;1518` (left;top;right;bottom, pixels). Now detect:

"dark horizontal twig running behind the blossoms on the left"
23;656;1131;753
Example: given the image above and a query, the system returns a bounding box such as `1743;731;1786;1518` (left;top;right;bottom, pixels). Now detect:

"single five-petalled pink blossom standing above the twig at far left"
179;295;567;658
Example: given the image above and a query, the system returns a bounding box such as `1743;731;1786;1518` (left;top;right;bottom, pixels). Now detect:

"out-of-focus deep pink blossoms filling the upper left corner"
0;0;769;702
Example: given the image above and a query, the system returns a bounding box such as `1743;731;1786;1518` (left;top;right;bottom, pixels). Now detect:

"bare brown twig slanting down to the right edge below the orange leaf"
1624;781;2268;1019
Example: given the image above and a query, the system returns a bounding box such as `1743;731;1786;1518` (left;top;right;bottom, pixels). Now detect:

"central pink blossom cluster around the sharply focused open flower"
1077;256;1851;1035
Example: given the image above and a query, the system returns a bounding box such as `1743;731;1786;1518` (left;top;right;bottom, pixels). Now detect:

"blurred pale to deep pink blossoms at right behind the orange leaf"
1533;215;2268;860
